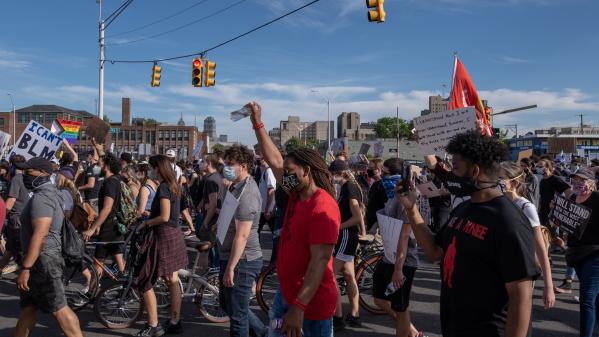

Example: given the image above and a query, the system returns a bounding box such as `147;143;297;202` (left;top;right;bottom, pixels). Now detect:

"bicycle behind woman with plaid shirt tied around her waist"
94;235;229;329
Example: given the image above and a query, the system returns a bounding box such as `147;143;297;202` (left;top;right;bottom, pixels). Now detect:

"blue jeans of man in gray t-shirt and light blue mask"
220;259;268;337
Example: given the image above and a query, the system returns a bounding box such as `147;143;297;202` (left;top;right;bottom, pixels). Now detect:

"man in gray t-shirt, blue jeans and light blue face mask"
218;145;267;337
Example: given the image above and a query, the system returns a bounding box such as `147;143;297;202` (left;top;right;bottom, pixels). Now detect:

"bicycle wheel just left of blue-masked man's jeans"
193;273;229;323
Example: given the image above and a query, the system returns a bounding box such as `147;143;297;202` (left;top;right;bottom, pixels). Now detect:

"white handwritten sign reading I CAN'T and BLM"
8;120;62;160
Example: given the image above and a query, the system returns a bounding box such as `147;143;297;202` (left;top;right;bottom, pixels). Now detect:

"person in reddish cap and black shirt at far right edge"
566;168;599;337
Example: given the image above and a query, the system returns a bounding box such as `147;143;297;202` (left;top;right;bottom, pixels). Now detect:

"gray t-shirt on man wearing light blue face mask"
219;177;262;261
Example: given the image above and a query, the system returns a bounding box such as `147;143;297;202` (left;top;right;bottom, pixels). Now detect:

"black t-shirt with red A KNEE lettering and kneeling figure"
435;196;539;337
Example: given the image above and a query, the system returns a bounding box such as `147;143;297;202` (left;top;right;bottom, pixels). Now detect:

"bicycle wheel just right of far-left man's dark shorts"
63;261;99;311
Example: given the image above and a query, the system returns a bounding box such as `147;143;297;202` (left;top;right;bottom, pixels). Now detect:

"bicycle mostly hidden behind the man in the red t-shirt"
256;236;385;315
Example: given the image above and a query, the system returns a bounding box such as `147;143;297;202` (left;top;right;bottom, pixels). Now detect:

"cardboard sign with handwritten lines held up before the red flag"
414;107;476;158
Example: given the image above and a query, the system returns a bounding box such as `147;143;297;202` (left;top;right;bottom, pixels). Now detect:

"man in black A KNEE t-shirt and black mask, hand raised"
399;131;539;337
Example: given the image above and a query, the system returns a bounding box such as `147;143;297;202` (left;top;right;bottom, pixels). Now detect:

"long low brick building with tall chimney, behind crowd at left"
0;97;206;159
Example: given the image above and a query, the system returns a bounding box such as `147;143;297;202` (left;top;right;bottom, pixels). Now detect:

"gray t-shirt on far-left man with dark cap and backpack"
21;183;64;255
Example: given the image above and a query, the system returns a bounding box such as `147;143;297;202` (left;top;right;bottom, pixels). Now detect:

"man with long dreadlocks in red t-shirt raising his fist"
251;102;341;337
